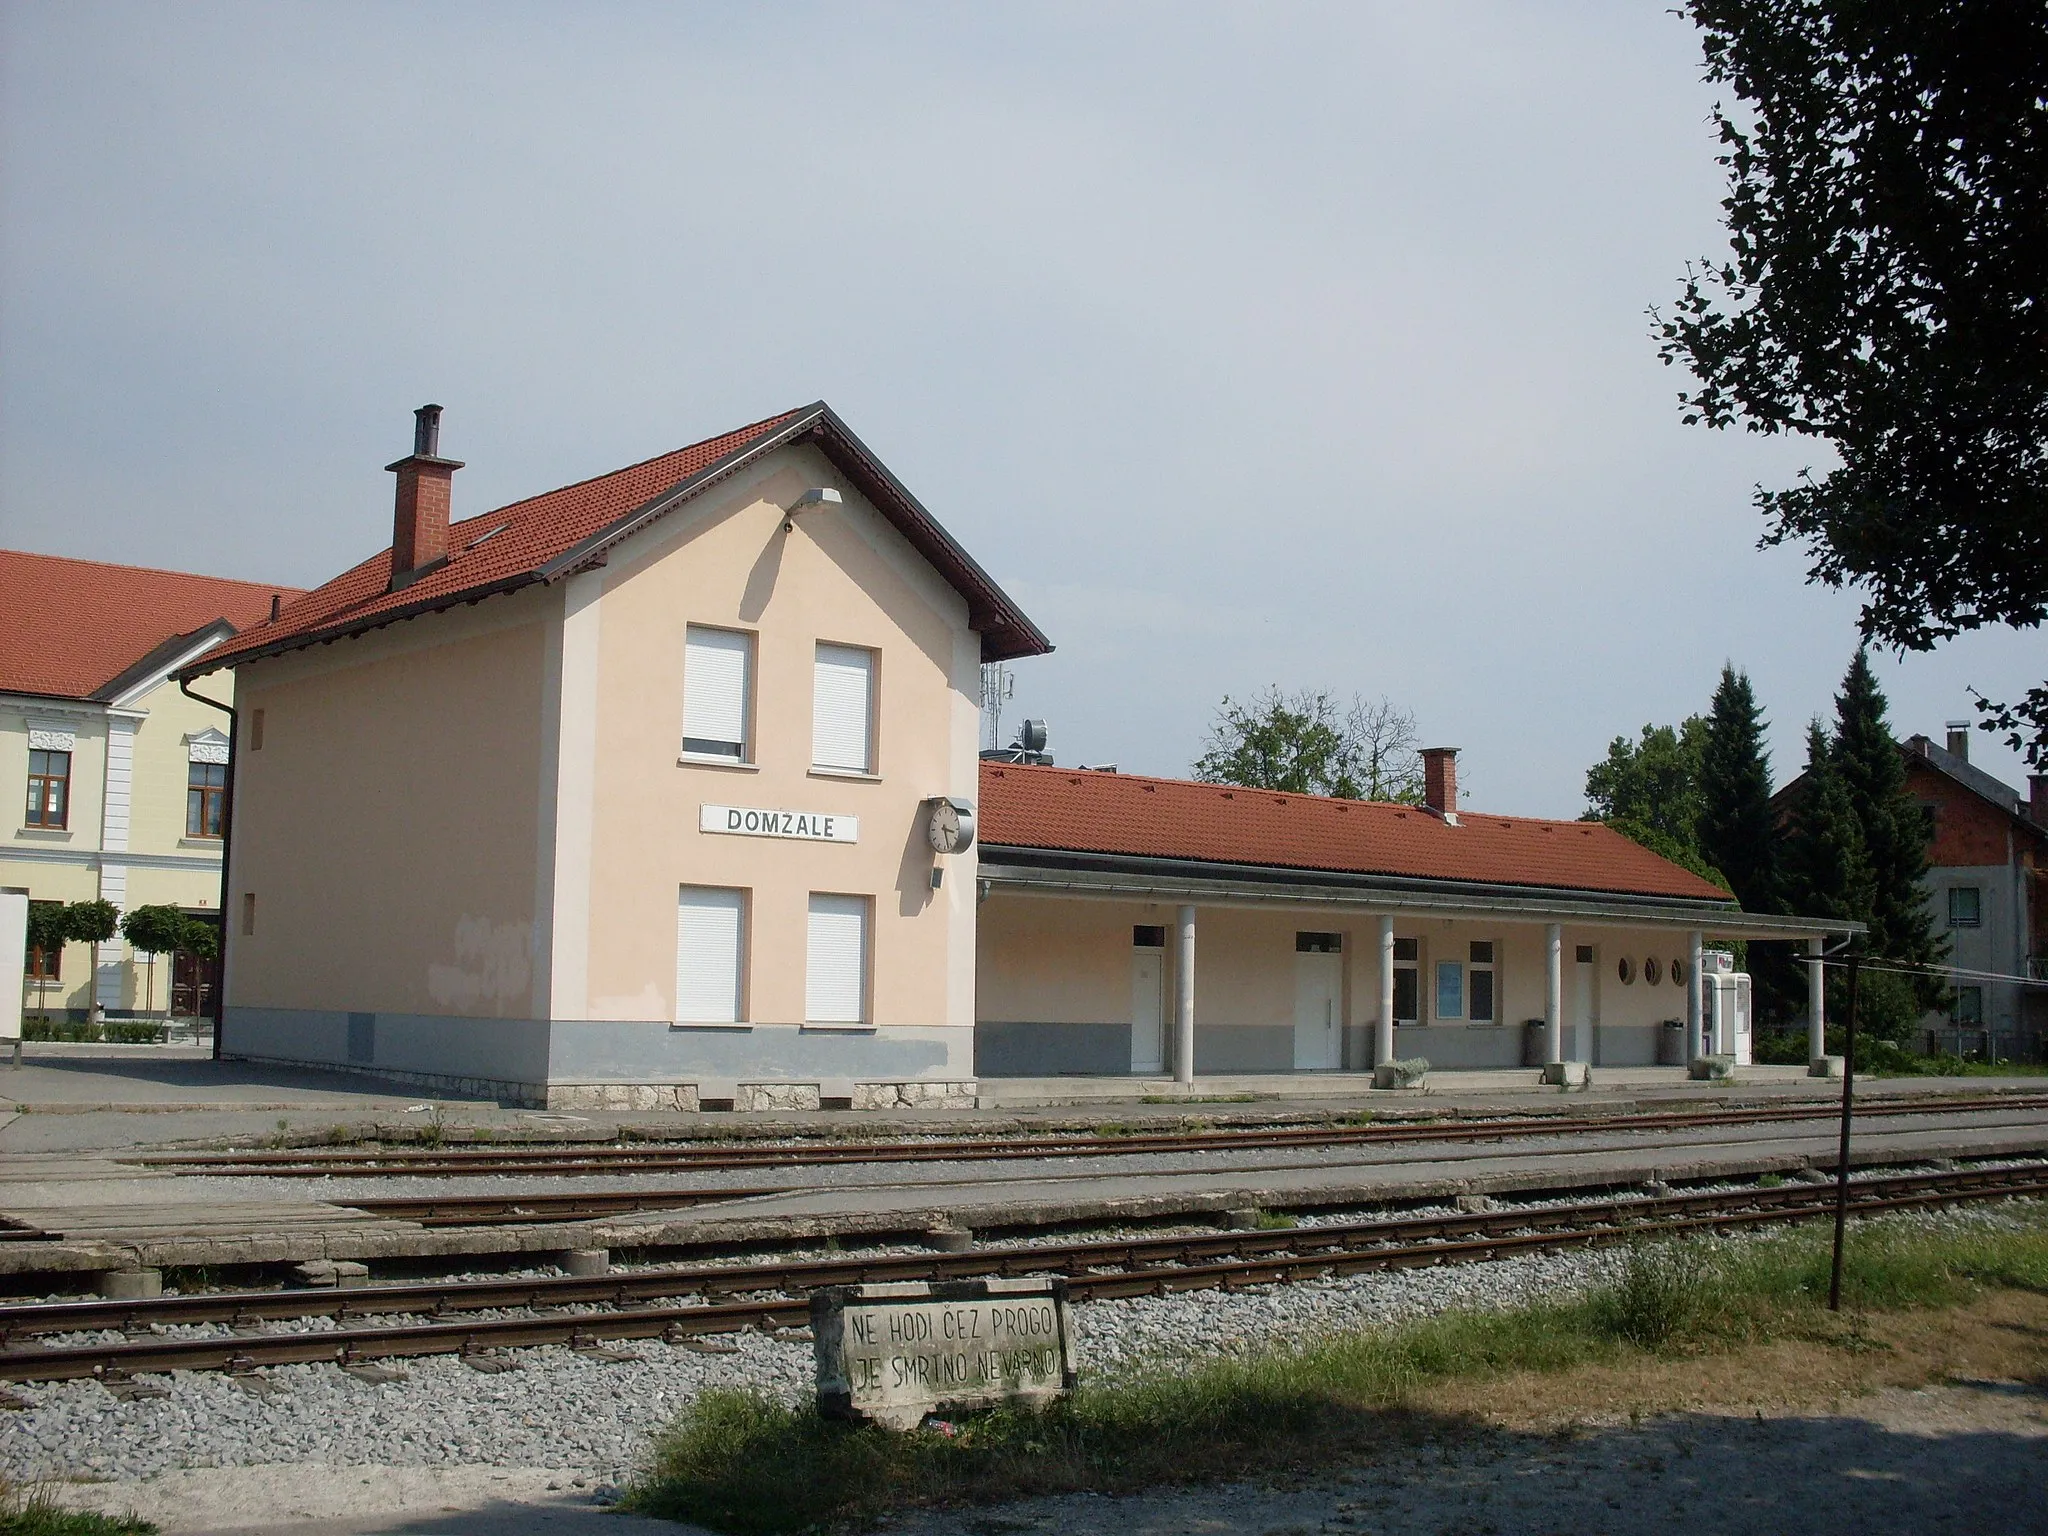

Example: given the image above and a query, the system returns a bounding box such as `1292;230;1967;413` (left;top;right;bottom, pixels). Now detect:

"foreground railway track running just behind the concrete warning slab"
0;1165;2048;1382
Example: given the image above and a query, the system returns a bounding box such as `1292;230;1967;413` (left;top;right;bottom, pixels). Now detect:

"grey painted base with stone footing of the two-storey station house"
221;1008;975;1110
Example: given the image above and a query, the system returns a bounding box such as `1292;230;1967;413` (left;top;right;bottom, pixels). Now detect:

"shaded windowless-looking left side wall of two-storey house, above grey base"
228;588;561;1018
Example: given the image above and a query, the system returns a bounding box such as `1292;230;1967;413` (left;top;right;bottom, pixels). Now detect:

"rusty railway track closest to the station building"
123;1096;2048;1194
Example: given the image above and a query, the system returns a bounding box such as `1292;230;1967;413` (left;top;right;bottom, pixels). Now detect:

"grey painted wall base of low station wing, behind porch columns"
975;1022;1659;1077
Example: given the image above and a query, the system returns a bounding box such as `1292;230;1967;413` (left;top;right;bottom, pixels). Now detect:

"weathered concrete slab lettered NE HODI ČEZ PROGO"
811;1276;1073;1430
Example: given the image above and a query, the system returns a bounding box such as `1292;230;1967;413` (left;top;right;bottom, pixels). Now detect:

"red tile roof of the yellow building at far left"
0;549;299;698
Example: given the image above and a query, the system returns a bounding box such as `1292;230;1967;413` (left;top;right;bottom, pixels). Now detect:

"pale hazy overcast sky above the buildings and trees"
0;0;2048;815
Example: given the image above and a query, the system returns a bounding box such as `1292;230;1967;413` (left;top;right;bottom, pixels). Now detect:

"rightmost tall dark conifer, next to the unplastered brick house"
1833;649;1948;1008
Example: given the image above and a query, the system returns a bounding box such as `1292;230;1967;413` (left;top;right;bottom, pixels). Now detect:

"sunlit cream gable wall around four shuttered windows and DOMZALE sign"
581;446;981;1028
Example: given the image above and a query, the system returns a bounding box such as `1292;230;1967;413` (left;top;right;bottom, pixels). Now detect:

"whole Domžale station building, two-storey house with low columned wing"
180;403;1839;1108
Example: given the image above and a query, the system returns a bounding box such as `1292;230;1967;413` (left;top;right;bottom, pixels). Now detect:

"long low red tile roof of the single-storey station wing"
977;762;1729;903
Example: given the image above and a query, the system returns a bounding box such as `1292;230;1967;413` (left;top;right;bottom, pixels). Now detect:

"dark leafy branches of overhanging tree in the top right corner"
1653;0;2048;764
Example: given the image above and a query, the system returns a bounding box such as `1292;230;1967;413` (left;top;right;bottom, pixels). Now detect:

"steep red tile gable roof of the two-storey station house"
195;401;1053;670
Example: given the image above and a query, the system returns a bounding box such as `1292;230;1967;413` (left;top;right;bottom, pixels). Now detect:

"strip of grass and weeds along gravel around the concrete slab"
627;1204;2048;1536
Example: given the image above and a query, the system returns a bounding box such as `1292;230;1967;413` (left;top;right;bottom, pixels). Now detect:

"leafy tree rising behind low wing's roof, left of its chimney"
1194;688;1421;805
